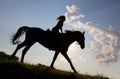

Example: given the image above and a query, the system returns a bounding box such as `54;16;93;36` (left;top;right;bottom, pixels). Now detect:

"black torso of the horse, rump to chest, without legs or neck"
26;28;69;52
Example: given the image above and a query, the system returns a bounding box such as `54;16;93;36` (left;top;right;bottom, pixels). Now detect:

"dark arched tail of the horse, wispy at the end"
12;26;29;44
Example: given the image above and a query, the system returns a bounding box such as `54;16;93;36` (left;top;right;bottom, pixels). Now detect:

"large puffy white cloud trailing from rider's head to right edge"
65;5;120;65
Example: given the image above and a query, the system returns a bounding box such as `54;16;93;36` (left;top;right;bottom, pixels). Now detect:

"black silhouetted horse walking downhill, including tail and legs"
11;26;85;73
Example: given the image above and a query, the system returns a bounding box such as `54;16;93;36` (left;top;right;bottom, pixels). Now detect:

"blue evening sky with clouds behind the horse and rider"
0;0;120;79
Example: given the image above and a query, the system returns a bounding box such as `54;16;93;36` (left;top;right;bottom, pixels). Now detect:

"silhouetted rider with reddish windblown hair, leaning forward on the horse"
52;16;66;33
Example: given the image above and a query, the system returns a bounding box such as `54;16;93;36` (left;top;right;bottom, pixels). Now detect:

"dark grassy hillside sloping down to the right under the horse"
0;52;109;79
